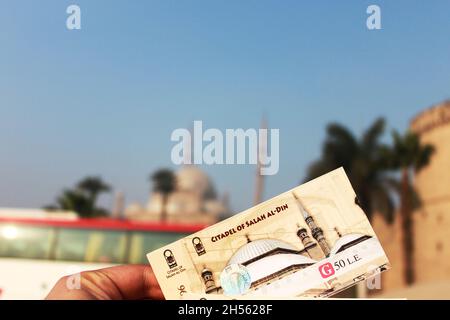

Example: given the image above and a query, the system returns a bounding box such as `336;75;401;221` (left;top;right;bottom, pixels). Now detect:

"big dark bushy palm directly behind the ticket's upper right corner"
306;118;394;221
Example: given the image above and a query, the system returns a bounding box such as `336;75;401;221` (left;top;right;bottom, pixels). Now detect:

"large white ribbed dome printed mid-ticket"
228;239;297;265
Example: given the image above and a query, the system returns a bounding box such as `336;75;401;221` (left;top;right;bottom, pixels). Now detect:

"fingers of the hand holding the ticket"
46;265;164;300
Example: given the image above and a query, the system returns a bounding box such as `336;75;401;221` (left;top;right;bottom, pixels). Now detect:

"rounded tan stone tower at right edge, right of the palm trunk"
411;100;450;282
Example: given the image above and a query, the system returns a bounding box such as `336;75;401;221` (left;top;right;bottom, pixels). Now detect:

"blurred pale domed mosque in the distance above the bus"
125;165;229;224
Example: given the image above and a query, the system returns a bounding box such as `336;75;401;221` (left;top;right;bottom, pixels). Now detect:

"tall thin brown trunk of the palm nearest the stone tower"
400;168;414;285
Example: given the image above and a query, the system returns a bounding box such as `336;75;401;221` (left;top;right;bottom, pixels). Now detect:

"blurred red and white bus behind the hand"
0;215;206;299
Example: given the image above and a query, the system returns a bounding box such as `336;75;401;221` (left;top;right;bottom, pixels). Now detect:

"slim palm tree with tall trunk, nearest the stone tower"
383;131;434;284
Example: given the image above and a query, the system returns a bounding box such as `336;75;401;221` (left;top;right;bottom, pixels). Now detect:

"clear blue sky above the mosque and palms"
0;0;450;214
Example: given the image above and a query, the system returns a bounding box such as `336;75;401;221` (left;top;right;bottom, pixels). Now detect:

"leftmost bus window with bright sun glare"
0;224;54;259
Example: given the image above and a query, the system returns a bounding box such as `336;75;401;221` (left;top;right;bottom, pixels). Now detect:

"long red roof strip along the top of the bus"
0;215;207;233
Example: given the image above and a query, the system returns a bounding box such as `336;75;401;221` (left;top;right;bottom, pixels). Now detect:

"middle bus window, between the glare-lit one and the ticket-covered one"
55;229;126;263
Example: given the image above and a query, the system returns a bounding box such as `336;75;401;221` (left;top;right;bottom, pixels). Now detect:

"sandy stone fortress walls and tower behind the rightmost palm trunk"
372;101;450;298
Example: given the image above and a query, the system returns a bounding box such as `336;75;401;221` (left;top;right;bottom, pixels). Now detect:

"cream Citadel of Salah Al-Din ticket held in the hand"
147;168;390;299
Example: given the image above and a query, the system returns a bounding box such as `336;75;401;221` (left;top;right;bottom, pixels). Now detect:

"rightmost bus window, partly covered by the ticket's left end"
128;231;188;263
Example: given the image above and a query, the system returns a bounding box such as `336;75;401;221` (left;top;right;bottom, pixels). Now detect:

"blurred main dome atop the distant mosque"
176;166;213;196
